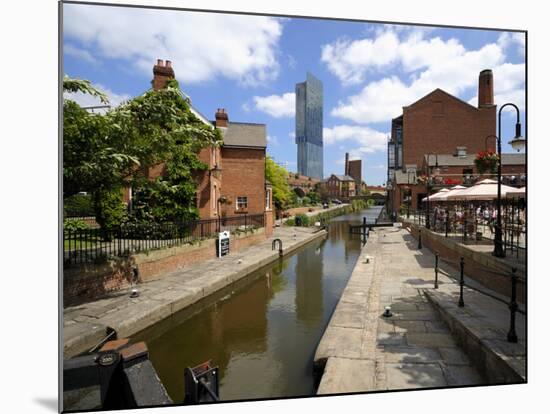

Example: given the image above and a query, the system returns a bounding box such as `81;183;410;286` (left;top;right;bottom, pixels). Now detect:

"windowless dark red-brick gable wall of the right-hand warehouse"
403;90;496;168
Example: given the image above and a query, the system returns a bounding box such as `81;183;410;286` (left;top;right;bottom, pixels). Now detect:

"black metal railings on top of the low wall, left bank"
63;214;264;266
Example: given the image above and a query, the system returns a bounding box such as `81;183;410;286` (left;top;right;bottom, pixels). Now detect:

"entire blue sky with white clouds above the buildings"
63;4;525;185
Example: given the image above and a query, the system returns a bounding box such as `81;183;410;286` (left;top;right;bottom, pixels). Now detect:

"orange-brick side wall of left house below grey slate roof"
221;147;265;216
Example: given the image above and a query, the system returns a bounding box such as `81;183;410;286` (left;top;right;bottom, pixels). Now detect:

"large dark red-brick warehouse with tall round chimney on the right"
387;69;525;211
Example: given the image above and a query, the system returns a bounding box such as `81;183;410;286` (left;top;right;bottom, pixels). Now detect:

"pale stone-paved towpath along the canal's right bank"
315;228;525;394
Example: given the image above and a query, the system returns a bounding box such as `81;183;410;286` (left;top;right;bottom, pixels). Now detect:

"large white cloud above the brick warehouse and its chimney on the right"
328;31;525;124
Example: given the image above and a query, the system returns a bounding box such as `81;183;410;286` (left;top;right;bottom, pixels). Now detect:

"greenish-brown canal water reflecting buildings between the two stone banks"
133;207;381;403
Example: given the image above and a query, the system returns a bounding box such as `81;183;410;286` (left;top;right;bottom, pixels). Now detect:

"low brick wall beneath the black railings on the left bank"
63;228;272;305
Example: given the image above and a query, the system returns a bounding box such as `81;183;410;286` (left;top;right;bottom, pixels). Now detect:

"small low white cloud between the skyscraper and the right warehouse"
323;125;387;154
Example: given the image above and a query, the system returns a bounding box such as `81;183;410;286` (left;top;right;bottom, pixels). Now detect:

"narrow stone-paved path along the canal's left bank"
63;227;326;358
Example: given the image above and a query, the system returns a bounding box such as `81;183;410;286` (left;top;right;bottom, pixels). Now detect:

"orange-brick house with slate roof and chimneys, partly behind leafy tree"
126;59;273;231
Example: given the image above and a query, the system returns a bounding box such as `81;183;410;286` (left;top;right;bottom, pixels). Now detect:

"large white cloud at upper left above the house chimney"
63;4;282;84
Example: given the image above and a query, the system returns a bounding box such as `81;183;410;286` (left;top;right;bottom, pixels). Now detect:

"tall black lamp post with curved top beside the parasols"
485;103;526;257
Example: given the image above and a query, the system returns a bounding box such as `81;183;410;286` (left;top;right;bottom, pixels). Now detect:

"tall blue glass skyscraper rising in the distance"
296;72;323;179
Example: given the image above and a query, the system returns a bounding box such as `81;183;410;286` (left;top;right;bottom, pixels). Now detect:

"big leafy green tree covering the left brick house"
63;76;221;225
